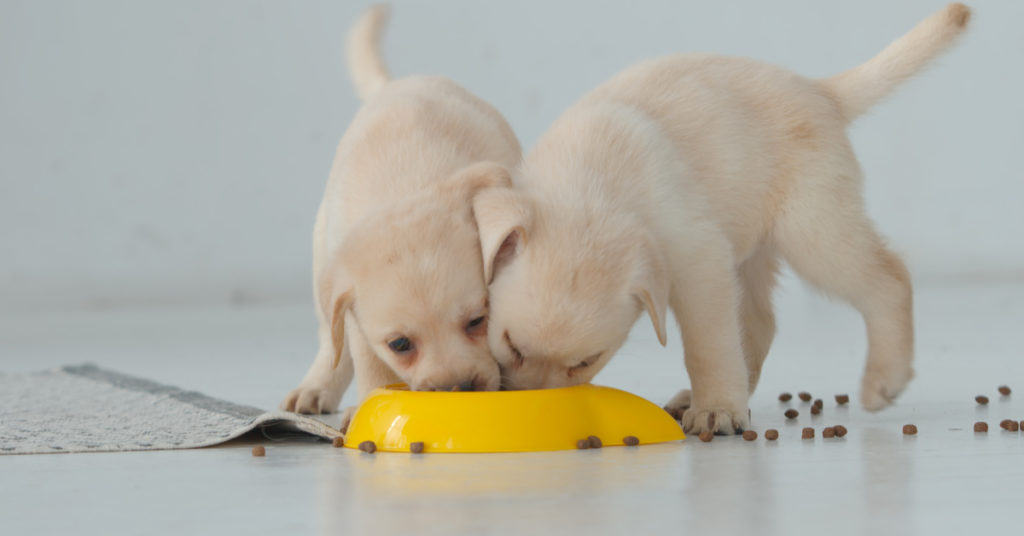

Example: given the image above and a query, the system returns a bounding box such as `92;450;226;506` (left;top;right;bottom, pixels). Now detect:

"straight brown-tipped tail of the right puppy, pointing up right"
820;3;971;121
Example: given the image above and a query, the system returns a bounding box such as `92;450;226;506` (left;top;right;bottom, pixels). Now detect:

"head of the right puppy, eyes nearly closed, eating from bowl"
474;190;669;389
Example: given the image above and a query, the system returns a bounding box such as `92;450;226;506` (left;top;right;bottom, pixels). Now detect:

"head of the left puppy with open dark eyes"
319;164;509;390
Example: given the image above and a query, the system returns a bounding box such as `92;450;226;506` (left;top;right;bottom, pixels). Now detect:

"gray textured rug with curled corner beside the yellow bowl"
0;365;340;454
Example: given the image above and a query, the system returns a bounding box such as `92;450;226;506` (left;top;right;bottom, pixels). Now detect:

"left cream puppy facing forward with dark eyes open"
282;7;521;413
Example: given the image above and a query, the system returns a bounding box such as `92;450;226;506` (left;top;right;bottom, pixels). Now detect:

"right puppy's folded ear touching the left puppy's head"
473;188;532;285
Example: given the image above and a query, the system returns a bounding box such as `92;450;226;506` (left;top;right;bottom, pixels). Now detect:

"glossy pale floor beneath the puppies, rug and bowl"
0;281;1024;535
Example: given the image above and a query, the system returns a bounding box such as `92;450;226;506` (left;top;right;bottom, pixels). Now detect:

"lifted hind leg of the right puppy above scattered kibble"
775;169;913;411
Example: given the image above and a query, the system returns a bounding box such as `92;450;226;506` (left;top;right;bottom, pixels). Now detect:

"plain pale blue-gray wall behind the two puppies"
0;0;1024;310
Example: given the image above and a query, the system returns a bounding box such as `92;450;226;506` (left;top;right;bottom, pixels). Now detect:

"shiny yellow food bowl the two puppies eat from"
345;384;685;452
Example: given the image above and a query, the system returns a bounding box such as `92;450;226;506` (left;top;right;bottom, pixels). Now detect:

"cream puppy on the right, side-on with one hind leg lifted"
474;4;970;434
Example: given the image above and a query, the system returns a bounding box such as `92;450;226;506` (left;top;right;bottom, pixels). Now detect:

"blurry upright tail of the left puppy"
346;4;391;100
